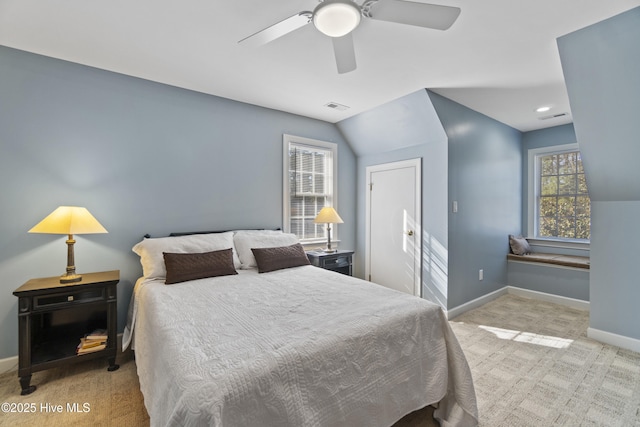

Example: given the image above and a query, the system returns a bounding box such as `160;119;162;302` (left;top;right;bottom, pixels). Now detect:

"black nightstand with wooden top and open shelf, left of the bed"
13;270;120;395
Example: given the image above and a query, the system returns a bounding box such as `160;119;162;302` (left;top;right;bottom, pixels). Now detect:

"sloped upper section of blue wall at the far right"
558;7;640;201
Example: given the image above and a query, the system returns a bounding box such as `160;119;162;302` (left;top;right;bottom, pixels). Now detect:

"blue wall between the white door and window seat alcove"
430;93;522;309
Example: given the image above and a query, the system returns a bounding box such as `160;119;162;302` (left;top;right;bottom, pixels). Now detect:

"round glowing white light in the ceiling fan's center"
313;0;360;37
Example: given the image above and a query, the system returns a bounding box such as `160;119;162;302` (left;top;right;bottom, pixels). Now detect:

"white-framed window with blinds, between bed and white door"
283;135;338;243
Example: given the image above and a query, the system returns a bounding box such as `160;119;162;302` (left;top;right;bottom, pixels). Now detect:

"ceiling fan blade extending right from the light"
365;0;460;30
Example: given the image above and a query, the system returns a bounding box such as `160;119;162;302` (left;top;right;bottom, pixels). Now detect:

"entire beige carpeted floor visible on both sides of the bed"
0;295;640;427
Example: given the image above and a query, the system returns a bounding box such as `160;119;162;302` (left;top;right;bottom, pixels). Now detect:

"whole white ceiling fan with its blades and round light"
238;0;460;74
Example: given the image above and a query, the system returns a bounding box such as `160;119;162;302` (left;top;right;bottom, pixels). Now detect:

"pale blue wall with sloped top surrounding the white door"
338;90;448;308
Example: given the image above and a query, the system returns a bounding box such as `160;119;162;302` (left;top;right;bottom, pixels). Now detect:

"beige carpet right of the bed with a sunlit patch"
451;295;640;427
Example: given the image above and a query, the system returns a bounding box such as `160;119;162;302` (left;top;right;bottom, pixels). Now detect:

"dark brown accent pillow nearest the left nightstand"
162;248;238;285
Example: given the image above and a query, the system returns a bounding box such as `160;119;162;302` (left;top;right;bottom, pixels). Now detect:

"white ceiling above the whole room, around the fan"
0;0;640;131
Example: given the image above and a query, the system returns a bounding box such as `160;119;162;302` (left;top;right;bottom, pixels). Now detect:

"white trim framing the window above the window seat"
527;142;591;249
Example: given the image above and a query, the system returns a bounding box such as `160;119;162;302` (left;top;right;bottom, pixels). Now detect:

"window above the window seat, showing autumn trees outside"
529;144;591;241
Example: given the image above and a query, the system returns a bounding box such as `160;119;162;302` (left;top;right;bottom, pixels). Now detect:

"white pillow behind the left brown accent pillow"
132;231;240;279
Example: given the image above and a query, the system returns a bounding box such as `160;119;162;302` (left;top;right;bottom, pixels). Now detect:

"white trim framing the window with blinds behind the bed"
282;133;340;244
